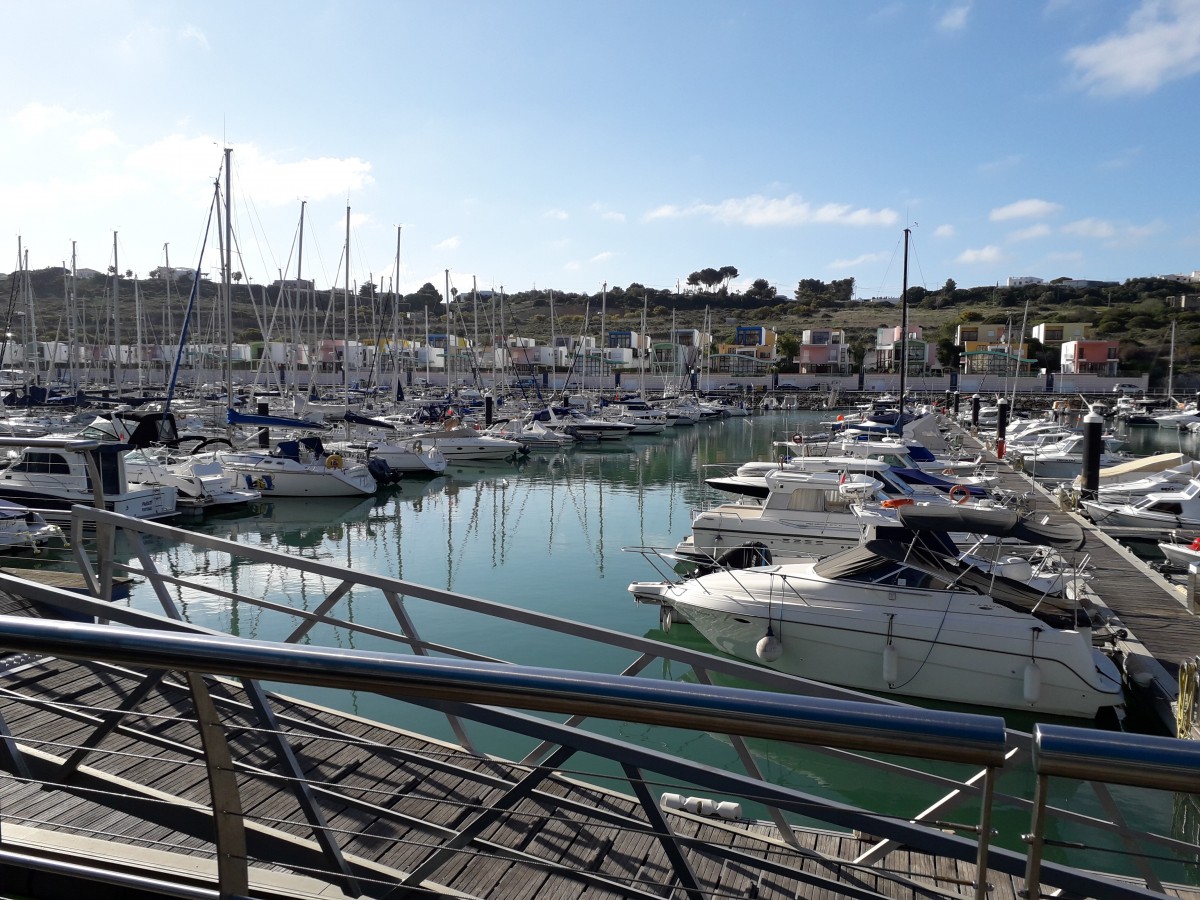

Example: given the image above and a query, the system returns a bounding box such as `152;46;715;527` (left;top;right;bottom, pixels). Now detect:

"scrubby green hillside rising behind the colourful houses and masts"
0;268;1200;376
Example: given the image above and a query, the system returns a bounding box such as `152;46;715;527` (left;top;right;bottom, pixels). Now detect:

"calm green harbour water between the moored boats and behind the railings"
96;412;1194;881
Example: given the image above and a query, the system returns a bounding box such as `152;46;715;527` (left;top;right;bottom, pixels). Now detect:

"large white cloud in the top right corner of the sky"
1067;0;1200;96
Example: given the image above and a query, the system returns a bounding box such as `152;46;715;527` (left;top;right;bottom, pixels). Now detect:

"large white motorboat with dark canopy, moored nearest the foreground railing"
629;506;1123;718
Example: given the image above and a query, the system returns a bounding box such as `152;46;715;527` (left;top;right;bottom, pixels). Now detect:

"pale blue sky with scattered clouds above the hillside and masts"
0;0;1200;298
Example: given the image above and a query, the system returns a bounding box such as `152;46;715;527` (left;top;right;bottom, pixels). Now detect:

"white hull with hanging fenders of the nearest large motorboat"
643;570;1123;719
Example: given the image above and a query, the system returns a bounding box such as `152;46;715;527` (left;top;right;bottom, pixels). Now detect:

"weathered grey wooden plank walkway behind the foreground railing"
0;598;1051;900
